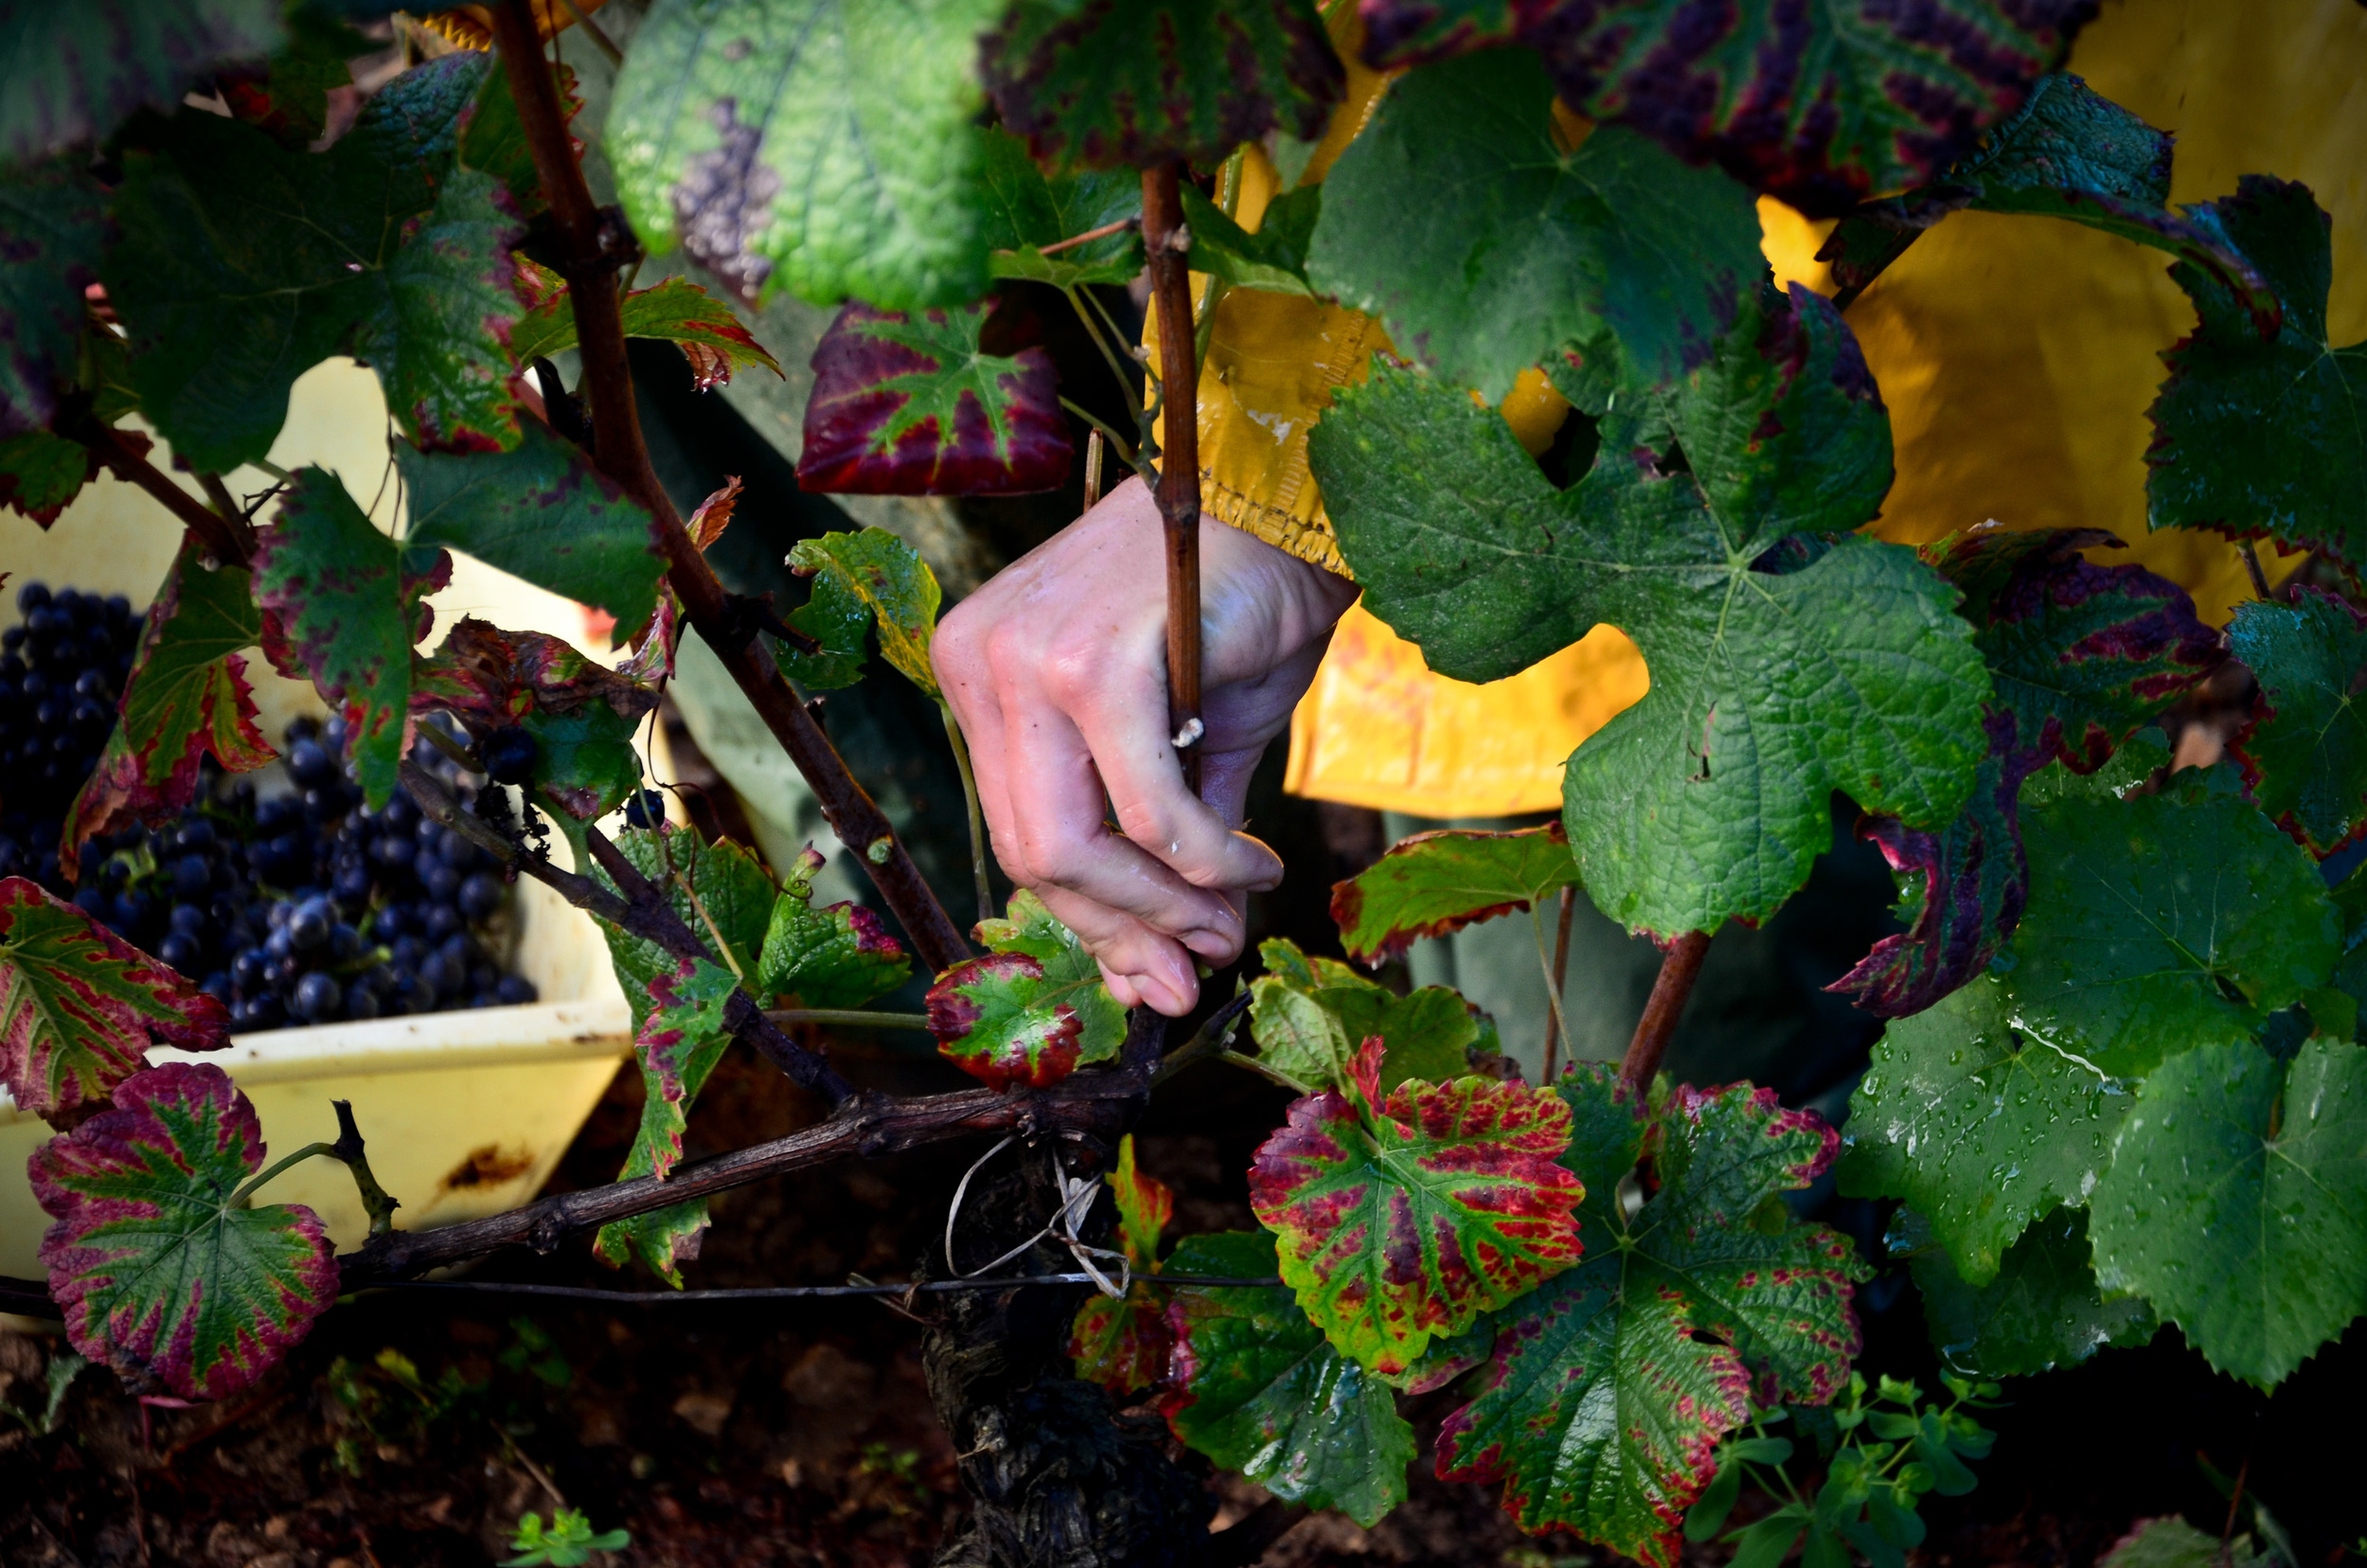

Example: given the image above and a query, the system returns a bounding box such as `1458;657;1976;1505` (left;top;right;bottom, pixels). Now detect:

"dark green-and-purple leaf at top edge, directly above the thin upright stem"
980;0;1347;169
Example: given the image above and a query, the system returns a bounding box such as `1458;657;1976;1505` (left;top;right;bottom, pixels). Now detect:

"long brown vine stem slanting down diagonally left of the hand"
492;0;970;969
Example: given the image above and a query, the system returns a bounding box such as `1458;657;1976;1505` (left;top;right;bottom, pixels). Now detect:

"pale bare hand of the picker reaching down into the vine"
928;478;1357;1016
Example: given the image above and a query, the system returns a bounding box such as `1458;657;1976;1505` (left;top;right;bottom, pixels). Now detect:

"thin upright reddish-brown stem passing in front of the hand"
1144;164;1207;793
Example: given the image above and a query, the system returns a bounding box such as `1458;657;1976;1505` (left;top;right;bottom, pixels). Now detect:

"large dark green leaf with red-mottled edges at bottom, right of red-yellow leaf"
1439;1063;1868;1568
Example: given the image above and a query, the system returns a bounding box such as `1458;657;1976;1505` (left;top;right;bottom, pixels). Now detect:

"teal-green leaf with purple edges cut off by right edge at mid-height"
2228;587;2367;860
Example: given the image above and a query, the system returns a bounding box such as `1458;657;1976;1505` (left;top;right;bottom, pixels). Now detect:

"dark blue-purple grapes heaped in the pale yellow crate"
0;582;535;1030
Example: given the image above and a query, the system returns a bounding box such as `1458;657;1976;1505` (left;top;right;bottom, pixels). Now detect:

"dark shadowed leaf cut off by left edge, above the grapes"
0;156;109;436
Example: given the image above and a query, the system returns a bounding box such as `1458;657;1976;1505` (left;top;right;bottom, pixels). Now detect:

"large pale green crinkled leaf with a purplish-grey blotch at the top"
604;0;1002;311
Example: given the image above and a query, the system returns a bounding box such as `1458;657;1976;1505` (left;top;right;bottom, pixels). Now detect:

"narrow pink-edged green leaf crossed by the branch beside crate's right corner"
592;959;739;1291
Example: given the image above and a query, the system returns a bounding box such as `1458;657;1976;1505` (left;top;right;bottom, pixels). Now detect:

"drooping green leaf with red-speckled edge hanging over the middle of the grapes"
254;469;415;808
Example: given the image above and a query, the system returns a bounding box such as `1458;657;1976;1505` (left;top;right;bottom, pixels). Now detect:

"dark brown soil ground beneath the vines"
0;1032;2362;1568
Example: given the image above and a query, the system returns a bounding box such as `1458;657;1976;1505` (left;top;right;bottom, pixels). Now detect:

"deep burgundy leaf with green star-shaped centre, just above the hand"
798;303;1070;495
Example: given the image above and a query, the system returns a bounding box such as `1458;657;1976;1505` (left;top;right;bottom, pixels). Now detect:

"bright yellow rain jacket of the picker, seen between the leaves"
1144;0;2367;817
